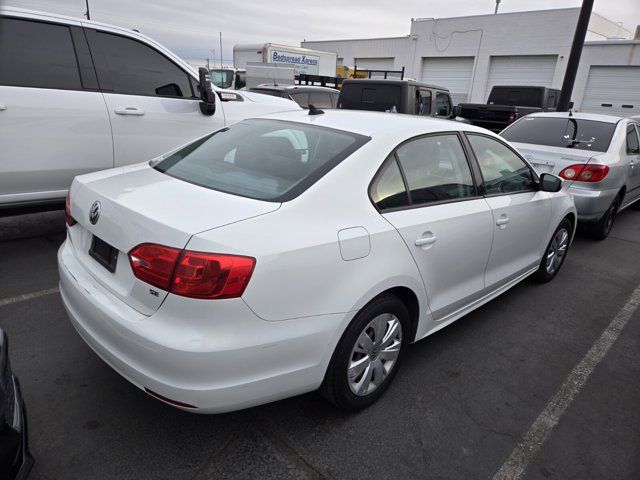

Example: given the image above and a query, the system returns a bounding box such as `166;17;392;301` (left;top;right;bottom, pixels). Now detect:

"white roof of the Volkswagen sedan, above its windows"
254;109;490;138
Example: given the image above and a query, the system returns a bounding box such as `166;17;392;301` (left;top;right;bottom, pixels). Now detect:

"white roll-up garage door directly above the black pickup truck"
484;55;558;101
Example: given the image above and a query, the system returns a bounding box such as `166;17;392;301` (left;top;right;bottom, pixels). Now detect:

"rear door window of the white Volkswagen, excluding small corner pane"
396;134;476;204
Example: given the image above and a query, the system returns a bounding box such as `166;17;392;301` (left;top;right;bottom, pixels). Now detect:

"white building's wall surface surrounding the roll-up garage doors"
302;8;638;104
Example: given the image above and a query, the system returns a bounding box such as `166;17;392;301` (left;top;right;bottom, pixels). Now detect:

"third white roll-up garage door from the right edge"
420;57;473;105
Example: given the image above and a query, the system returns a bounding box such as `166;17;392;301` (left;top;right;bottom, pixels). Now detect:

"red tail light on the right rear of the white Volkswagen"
129;243;256;299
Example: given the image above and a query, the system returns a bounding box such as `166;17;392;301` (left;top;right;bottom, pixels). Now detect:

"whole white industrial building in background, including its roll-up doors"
302;8;640;115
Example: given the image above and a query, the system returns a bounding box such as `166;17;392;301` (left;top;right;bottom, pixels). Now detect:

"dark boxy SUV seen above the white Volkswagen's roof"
338;79;453;118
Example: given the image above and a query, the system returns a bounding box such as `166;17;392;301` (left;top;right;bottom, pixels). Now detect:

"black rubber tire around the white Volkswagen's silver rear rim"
319;294;411;411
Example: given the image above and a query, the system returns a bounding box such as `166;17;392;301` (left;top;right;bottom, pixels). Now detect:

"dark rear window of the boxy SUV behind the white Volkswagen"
338;83;402;112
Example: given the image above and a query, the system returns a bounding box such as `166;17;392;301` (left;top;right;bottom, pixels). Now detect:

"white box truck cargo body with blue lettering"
233;43;338;77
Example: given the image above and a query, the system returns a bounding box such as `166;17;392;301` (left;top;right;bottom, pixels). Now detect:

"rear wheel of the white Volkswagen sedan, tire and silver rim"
320;295;409;410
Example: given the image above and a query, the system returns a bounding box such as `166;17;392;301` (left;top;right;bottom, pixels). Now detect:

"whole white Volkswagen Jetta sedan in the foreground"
58;109;576;413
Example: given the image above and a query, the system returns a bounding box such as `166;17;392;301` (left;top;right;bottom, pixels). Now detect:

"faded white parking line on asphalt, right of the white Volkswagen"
493;285;640;480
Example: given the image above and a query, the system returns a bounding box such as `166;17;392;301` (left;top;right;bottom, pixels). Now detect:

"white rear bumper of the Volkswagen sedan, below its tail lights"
58;242;353;413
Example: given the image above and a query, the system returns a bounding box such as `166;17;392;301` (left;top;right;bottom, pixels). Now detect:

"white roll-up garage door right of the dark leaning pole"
580;66;640;116
